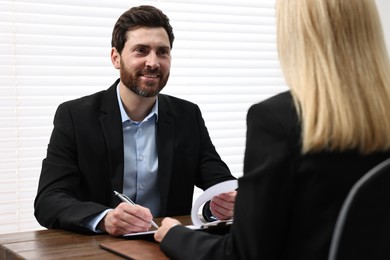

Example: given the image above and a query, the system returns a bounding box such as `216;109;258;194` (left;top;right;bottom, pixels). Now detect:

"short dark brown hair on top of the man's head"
111;5;175;53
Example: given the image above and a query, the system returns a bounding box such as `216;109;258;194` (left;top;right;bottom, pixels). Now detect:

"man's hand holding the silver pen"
98;202;153;236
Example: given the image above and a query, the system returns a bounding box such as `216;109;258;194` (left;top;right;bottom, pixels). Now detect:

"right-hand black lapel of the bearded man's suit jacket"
157;94;175;215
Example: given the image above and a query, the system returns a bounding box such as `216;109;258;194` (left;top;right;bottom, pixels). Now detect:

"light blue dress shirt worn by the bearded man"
83;84;160;233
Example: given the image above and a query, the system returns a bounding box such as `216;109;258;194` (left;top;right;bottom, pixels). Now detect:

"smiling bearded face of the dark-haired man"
114;27;171;97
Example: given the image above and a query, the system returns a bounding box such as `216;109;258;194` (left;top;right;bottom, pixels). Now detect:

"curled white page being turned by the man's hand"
191;180;238;228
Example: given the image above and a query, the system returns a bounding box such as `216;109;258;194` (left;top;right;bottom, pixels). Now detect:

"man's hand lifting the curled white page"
210;191;237;220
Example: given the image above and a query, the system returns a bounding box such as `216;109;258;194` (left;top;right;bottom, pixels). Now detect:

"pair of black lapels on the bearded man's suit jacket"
96;86;175;212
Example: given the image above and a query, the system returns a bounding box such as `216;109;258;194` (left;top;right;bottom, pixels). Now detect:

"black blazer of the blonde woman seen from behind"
161;92;390;260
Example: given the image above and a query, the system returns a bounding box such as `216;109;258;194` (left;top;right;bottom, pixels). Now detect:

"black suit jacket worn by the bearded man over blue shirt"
34;80;234;232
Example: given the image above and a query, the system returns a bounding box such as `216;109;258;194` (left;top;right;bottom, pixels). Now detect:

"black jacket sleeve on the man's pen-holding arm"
34;104;108;232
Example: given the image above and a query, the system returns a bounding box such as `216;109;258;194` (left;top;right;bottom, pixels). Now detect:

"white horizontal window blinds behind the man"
0;0;286;233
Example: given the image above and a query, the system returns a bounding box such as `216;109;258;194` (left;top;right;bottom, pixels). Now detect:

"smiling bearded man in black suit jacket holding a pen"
34;6;236;235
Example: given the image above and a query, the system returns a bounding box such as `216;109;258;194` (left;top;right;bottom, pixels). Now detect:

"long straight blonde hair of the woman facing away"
276;0;390;154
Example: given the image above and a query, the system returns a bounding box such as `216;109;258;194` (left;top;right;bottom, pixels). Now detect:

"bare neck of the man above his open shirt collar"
119;84;157;122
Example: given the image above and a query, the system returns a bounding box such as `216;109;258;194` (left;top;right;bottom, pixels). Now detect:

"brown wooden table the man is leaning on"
0;216;191;260
